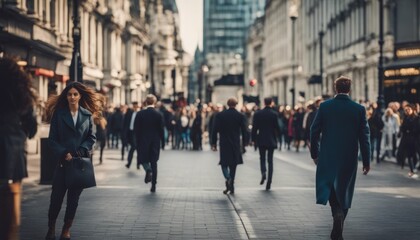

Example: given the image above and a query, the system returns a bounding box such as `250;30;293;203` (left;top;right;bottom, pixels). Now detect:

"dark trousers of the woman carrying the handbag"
48;166;83;221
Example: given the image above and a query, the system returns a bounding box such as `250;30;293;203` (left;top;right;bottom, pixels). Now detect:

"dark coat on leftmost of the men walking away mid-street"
134;107;165;164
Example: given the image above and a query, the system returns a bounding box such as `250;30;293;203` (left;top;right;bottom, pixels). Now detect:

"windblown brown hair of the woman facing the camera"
46;82;104;122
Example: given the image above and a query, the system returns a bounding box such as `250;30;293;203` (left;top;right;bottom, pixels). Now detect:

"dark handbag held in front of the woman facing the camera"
65;157;96;188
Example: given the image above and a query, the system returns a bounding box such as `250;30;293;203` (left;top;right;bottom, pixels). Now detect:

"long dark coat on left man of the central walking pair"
211;108;247;166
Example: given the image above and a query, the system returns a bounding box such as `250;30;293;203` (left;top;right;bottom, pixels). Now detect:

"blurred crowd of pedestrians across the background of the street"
100;91;420;178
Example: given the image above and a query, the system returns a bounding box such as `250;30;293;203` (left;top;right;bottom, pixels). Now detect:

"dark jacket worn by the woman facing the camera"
48;107;96;163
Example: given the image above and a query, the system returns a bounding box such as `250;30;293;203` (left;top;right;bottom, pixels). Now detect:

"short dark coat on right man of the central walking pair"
252;107;280;148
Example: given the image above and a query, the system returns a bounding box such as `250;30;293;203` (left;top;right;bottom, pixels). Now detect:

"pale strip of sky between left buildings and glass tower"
176;0;203;56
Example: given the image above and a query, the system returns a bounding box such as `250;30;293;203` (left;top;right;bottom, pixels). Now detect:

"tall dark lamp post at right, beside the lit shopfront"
377;0;385;114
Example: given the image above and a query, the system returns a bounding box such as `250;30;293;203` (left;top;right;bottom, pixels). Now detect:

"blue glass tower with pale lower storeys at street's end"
203;0;265;101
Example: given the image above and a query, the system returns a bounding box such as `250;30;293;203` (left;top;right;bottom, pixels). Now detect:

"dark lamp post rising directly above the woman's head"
69;0;83;82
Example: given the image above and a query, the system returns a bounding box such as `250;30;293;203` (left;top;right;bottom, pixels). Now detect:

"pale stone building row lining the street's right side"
254;0;420;105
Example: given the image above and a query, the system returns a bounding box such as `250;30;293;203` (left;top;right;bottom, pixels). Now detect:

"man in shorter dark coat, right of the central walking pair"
252;98;280;190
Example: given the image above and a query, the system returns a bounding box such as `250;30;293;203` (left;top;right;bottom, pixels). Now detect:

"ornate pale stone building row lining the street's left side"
0;0;188;109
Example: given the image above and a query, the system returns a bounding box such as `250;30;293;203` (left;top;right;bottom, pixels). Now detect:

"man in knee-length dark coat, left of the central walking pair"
211;98;247;194
